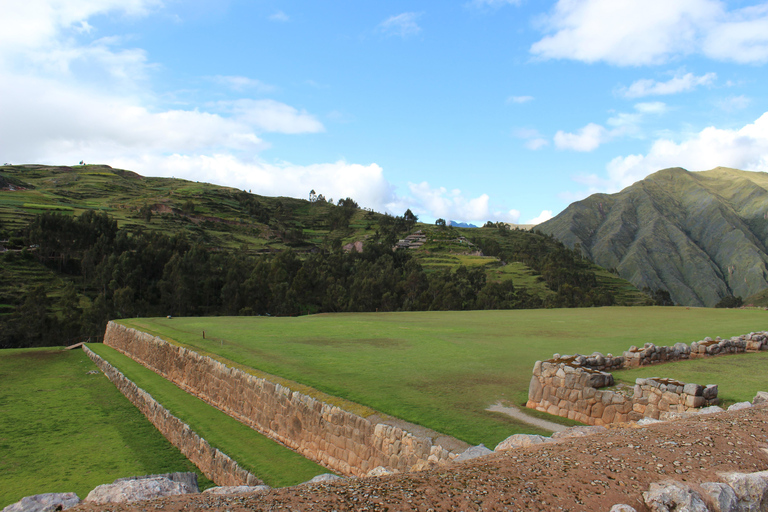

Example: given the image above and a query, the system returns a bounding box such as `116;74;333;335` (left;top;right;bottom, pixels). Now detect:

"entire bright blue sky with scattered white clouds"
0;0;768;223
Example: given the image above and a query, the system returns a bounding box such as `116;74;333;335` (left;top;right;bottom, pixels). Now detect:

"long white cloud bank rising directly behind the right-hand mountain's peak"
600;112;768;192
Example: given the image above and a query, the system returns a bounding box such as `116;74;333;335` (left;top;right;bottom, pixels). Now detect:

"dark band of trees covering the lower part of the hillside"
0;209;613;348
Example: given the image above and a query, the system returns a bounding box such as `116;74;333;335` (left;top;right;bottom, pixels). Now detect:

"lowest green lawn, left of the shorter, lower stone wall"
0;349;213;508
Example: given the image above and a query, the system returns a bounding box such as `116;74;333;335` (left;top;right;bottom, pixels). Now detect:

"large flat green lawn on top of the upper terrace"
121;307;768;446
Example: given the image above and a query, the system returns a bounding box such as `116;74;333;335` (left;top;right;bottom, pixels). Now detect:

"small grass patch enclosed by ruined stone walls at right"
613;352;768;407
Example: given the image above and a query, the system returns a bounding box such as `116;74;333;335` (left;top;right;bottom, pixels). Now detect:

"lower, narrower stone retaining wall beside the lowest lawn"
83;345;264;485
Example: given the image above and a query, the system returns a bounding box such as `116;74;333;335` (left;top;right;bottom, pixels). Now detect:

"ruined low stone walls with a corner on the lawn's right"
526;332;768;425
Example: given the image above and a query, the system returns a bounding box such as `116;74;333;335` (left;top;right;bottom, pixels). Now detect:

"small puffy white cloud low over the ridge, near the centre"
405;181;490;221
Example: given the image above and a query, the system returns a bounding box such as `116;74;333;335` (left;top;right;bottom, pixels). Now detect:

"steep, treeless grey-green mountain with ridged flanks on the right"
537;167;768;306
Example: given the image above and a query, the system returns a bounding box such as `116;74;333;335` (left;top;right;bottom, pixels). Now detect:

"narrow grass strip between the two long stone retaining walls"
88;343;328;487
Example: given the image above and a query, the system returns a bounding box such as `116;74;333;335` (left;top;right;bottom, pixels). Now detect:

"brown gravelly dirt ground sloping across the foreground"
70;406;768;512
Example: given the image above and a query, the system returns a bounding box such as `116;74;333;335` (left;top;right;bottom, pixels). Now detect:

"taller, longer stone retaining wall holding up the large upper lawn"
104;322;451;476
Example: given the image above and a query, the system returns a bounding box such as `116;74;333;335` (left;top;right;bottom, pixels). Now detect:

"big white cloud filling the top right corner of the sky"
531;0;768;66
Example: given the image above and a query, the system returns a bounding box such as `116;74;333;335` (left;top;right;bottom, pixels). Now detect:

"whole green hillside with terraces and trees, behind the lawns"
0;166;650;348
